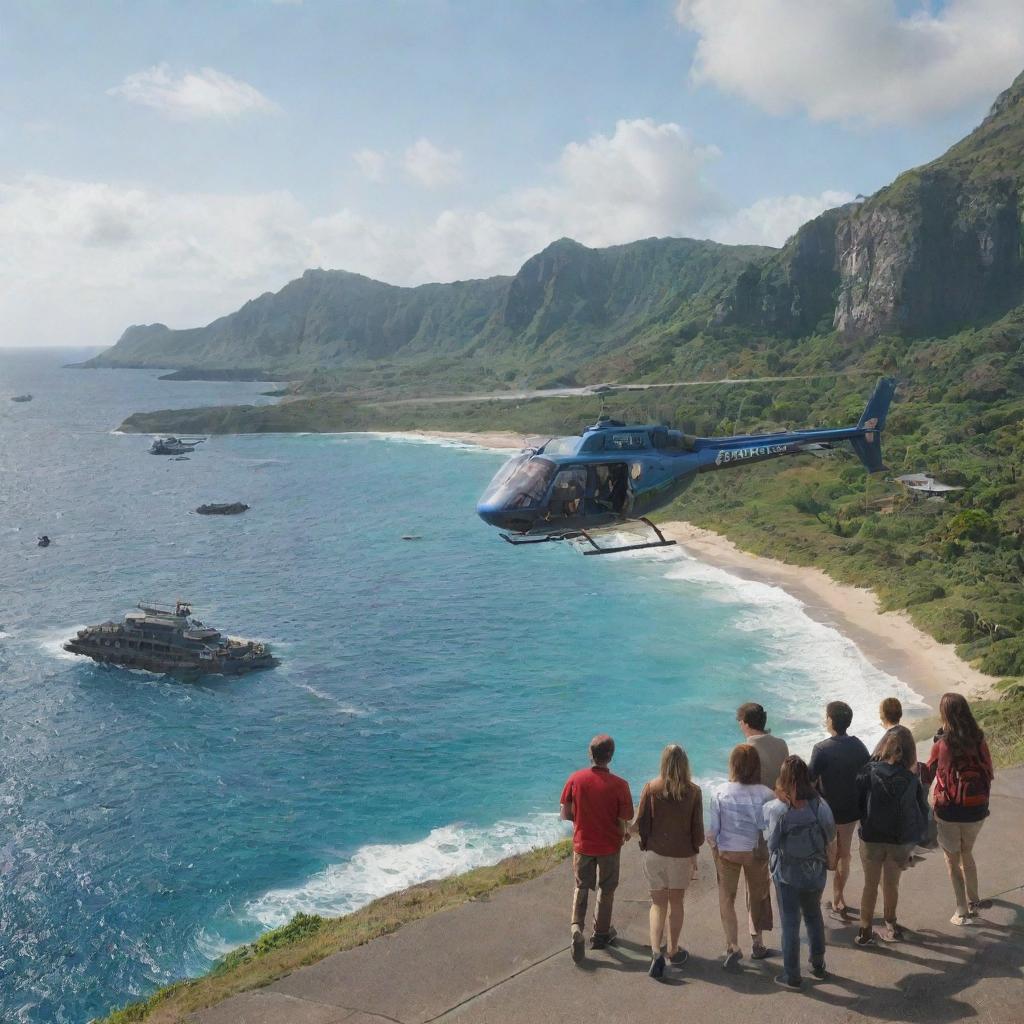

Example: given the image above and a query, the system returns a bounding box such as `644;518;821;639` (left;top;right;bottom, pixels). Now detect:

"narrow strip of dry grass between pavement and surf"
96;840;571;1024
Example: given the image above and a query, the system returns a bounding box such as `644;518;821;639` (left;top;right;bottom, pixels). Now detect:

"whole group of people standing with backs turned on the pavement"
561;693;993;989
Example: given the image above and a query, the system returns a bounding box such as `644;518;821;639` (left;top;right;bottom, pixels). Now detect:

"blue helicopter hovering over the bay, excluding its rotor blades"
476;377;896;555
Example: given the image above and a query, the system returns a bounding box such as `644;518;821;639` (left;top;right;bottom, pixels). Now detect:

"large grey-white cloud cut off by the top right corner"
676;0;1024;124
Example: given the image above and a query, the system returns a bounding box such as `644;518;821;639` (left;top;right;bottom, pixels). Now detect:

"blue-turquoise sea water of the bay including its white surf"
0;351;913;1024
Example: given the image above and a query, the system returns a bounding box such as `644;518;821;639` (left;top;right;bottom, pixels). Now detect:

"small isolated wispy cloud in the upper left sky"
106;63;279;121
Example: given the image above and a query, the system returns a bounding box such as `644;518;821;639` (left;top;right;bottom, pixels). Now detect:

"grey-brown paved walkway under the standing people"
189;769;1024;1024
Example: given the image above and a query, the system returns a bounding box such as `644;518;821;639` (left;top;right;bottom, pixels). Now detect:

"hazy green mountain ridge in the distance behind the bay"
86;239;773;383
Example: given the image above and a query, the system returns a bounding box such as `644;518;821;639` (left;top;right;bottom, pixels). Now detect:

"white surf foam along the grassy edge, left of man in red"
230;814;566;948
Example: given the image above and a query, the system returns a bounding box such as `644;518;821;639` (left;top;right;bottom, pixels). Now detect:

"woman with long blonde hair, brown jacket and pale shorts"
633;743;705;978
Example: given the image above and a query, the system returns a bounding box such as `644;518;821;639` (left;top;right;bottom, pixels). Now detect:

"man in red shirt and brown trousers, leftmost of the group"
561;734;633;964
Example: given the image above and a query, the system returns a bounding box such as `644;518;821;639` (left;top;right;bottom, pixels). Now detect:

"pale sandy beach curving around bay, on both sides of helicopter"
382;430;997;713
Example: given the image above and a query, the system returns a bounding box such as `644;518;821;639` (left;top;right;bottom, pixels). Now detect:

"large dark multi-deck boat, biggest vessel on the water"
63;601;280;679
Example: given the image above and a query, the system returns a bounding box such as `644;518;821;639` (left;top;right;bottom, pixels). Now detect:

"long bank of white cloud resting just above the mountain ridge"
0;120;849;345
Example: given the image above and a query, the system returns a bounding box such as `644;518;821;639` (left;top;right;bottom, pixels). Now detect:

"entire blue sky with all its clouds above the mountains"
0;0;1024;346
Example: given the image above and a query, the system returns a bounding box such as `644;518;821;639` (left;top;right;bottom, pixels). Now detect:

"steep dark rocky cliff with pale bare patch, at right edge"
718;70;1024;337
